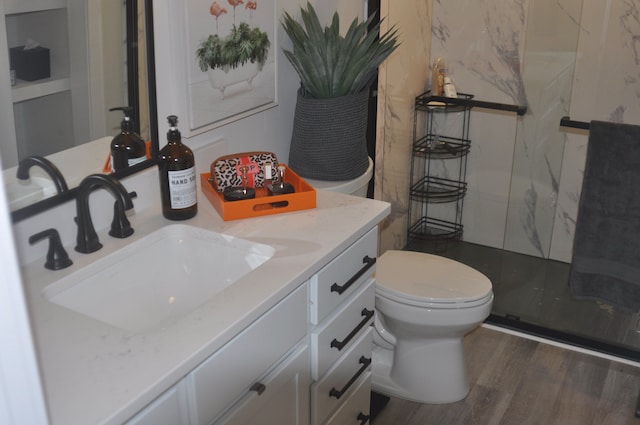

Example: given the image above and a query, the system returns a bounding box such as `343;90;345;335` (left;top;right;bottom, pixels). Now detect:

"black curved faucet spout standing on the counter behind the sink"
75;174;133;254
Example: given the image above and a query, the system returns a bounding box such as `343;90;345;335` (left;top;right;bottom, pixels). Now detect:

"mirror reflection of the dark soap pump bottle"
109;106;147;171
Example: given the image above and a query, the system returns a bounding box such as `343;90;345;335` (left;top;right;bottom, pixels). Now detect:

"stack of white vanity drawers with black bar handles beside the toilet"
309;228;378;425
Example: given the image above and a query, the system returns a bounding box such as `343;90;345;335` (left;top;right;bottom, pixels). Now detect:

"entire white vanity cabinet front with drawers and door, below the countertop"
119;227;378;425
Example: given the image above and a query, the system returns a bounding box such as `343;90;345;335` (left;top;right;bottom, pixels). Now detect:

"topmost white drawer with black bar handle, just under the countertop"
310;227;378;325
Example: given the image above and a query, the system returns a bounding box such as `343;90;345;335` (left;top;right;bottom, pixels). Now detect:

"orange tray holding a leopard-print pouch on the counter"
200;167;316;221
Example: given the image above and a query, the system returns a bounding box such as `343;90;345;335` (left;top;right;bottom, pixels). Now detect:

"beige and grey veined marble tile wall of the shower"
376;0;640;261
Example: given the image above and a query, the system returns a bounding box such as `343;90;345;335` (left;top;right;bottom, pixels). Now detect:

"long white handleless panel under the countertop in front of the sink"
186;285;307;425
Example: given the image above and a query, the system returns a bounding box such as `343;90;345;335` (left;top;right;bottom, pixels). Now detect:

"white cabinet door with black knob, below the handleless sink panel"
215;345;310;425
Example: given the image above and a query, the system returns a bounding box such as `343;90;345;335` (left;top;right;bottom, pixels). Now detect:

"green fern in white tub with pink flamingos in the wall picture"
196;0;271;93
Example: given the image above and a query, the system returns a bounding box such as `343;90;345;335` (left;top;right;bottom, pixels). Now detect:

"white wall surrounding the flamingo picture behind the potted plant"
153;0;364;162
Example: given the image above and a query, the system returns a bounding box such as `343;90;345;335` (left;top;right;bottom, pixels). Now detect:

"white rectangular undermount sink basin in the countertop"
44;224;274;332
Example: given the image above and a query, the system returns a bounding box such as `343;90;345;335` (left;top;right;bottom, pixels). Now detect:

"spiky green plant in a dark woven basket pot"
282;3;398;181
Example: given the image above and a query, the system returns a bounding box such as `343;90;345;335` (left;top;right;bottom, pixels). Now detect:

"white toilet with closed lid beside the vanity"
372;250;493;404
